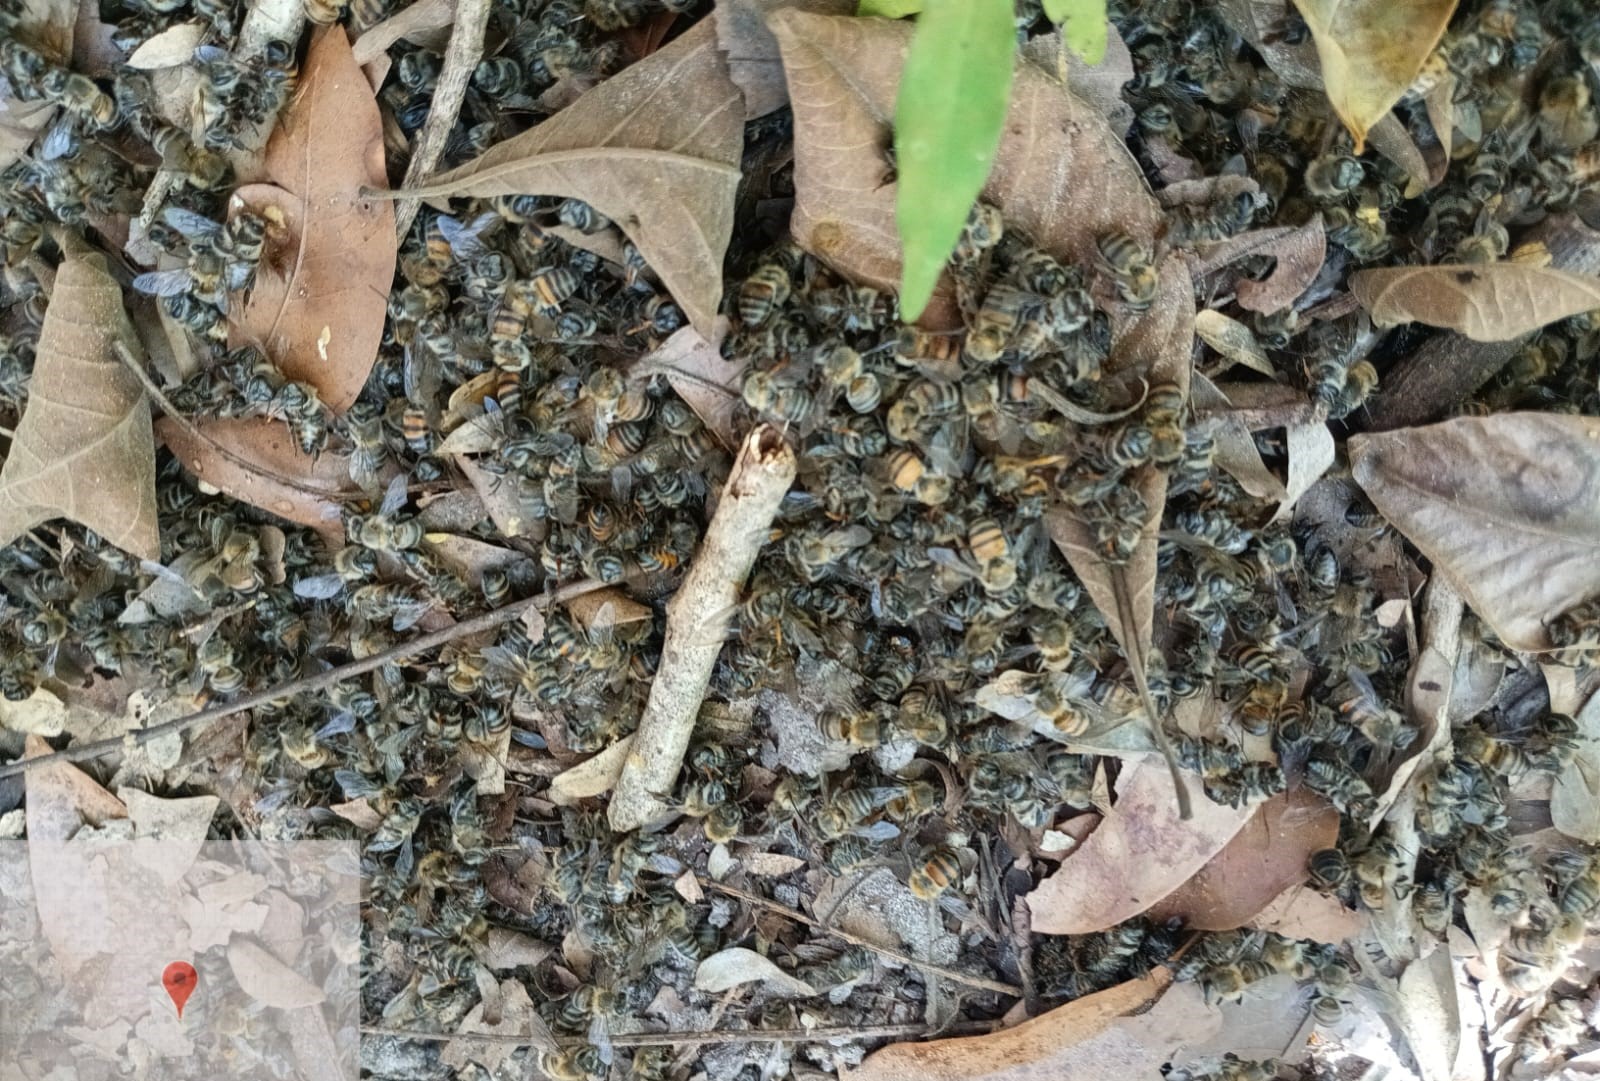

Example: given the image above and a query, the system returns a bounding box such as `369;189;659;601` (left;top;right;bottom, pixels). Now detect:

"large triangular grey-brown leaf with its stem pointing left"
406;21;744;334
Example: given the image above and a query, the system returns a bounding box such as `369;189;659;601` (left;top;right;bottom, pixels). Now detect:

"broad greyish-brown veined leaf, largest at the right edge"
1350;413;1600;649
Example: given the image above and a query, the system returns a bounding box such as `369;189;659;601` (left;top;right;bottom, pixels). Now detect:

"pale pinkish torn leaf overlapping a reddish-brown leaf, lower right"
1027;758;1254;934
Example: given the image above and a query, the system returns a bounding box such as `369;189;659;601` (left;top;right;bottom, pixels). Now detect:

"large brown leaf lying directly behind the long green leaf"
770;11;1162;321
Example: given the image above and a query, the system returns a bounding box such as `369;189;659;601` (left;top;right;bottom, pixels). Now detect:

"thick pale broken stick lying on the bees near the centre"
608;424;795;832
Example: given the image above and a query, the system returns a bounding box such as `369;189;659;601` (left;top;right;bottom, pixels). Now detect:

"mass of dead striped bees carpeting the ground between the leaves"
0;0;1600;1081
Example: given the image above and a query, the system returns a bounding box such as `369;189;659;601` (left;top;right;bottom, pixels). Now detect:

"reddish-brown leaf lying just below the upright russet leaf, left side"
155;417;362;531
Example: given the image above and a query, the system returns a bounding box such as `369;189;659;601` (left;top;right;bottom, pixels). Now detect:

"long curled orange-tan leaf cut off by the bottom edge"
845;969;1222;1081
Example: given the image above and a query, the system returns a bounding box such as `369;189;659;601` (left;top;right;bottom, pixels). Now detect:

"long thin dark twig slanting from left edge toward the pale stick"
0;582;605;777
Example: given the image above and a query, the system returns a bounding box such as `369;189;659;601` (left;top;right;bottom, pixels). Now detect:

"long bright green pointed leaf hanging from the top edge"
894;0;1016;320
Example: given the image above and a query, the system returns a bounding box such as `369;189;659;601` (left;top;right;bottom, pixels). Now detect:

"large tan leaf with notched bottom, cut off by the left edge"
0;256;160;560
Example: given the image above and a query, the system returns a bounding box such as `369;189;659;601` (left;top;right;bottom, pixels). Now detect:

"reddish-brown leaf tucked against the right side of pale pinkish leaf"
1149;788;1339;931
